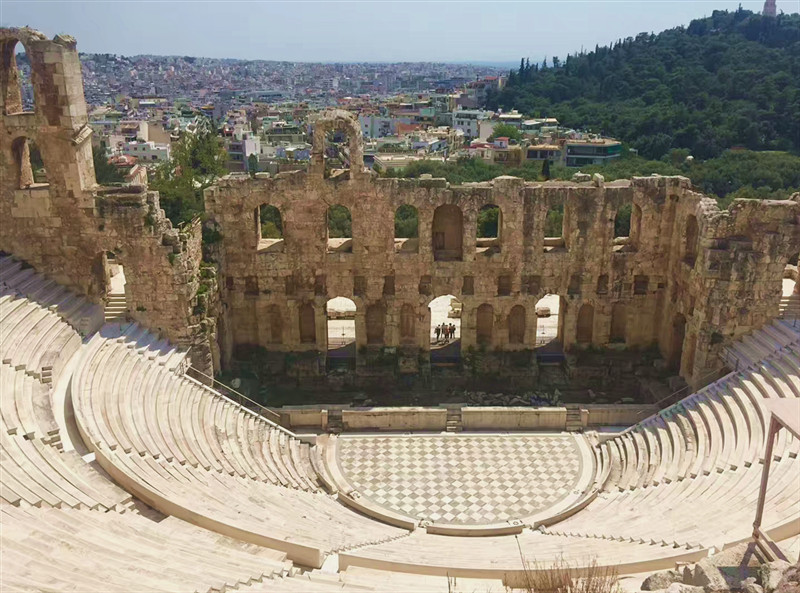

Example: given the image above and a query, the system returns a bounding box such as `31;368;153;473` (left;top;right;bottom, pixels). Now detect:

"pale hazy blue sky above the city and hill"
0;0;798;62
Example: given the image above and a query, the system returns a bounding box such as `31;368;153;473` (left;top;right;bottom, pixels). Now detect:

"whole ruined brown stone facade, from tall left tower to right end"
0;29;800;387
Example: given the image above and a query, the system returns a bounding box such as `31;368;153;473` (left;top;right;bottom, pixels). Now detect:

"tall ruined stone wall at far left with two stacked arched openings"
0;29;211;370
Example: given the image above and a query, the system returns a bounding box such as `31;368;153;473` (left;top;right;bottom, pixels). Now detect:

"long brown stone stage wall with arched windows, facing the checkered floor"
206;112;800;384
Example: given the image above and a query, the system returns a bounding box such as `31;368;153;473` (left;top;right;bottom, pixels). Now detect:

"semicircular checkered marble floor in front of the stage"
337;434;592;525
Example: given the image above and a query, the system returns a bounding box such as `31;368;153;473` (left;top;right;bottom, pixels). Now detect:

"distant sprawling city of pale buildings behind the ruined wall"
17;49;622;182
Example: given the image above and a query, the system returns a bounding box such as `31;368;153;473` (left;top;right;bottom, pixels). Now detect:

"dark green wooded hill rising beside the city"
488;8;800;159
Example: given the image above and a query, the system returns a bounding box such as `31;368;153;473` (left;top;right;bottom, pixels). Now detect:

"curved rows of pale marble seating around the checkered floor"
0;257;800;591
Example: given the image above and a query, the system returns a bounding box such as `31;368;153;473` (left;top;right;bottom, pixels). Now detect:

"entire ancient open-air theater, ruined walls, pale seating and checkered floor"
0;29;800;592
